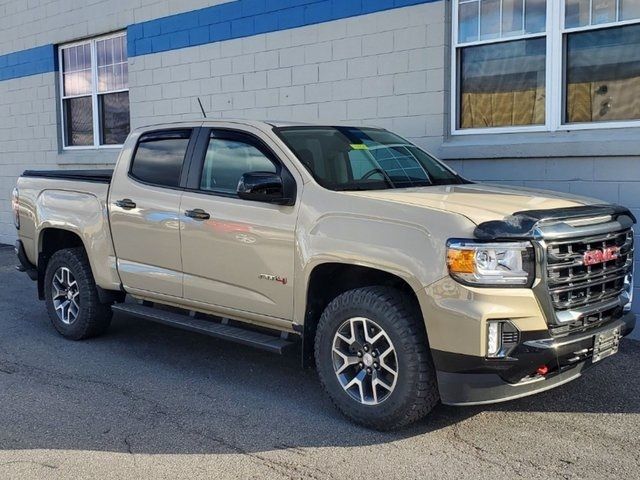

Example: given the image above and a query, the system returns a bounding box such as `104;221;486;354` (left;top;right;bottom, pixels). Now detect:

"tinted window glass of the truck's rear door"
131;130;191;187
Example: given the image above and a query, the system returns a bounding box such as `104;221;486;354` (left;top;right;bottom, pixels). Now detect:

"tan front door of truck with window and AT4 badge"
180;130;297;320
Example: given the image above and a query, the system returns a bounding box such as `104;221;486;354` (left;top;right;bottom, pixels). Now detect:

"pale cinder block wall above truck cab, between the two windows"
130;2;446;149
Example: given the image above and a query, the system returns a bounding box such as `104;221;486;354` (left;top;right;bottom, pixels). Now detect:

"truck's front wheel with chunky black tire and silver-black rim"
315;287;439;430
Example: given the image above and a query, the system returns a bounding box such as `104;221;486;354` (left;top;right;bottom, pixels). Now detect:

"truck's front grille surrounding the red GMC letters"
546;229;633;327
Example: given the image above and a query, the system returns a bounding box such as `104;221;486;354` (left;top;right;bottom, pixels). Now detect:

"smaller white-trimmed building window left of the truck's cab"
58;33;130;148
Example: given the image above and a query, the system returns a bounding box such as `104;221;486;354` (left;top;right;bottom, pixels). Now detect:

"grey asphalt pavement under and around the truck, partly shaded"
0;247;640;480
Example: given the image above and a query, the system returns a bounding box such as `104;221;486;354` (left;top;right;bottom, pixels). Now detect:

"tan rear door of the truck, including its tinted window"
109;128;199;298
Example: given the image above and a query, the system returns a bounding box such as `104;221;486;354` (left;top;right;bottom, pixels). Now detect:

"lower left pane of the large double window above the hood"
459;38;546;128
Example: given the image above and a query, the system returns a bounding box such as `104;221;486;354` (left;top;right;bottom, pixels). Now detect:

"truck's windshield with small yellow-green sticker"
275;127;467;190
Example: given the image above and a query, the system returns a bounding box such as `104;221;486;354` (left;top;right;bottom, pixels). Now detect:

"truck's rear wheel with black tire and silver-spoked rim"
44;248;111;340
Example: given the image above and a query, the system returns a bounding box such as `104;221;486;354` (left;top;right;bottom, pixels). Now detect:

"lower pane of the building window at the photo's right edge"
566;25;640;123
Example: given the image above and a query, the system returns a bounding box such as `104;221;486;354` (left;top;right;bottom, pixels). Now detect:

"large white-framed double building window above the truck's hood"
451;0;640;133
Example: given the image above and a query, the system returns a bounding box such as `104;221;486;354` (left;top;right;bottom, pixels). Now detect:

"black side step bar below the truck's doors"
111;303;295;355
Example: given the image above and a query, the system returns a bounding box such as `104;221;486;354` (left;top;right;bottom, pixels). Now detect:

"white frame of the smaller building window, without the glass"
58;31;131;150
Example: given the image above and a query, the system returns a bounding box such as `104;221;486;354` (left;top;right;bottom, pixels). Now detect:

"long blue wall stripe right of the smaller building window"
127;0;441;57
